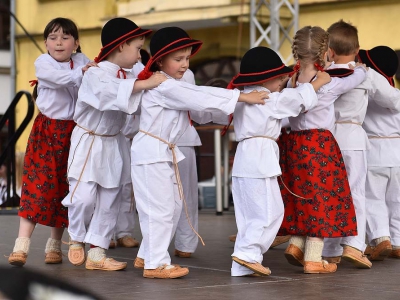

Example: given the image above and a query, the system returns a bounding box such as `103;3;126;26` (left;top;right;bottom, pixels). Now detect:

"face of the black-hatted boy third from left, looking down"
158;48;192;79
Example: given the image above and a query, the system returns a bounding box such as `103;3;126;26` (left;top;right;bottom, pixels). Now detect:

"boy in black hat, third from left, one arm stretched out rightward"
131;27;266;278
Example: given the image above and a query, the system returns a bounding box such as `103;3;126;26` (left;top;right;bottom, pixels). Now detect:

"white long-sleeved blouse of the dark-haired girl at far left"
35;53;90;120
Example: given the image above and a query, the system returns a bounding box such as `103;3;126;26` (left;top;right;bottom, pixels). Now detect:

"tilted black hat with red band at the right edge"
358;46;399;86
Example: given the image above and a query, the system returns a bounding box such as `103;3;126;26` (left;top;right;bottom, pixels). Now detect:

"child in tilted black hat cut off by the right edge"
358;46;400;260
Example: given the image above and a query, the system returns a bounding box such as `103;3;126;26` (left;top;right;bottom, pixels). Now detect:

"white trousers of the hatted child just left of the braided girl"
231;177;284;276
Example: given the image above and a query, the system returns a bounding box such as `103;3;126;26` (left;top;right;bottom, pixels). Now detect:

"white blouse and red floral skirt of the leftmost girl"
18;53;89;228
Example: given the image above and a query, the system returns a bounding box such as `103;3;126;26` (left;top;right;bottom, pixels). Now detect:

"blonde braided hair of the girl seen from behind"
292;26;329;86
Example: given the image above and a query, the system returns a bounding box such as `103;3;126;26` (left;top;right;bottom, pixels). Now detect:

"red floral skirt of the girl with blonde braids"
278;129;357;238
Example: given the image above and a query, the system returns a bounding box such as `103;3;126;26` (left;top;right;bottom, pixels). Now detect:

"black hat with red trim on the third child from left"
139;27;203;79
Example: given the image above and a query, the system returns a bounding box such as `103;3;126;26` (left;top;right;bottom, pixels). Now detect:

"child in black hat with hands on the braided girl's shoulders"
230;47;330;276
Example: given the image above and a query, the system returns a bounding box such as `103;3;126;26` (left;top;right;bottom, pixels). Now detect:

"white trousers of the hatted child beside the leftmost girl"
62;179;121;249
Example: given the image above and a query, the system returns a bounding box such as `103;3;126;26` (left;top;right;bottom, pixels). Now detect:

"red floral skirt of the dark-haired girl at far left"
18;113;75;228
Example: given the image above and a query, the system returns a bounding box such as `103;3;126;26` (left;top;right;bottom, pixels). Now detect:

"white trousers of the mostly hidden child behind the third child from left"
175;146;199;253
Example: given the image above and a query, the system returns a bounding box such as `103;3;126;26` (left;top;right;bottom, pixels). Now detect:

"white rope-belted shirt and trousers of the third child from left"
131;75;244;269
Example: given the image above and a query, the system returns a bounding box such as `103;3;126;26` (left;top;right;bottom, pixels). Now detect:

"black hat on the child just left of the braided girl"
231;47;293;86
